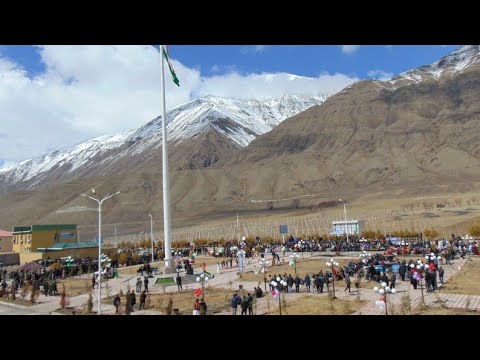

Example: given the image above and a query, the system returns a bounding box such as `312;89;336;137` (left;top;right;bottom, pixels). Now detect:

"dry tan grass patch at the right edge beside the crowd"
441;258;480;295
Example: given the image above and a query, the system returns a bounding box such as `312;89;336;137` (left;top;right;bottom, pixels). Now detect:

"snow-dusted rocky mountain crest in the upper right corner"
380;45;480;87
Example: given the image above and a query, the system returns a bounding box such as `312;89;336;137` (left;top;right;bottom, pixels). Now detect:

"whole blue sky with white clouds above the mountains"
0;45;459;169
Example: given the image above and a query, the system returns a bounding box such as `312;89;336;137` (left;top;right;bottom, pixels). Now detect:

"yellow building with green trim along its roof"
13;224;78;253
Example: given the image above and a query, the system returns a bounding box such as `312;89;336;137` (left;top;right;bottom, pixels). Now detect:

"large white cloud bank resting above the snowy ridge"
0;45;358;167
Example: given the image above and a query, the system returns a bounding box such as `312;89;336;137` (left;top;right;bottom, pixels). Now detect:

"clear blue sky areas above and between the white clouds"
0;45;459;79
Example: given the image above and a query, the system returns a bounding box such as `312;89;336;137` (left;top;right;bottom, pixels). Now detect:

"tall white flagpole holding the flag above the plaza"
160;45;174;273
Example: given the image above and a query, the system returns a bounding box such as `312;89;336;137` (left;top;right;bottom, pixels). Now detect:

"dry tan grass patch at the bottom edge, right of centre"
267;295;364;315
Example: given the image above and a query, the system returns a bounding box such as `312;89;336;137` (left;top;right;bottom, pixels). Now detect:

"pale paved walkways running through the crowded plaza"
0;253;480;315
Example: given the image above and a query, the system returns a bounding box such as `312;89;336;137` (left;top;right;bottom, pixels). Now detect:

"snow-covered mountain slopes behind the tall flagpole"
0;95;328;189
